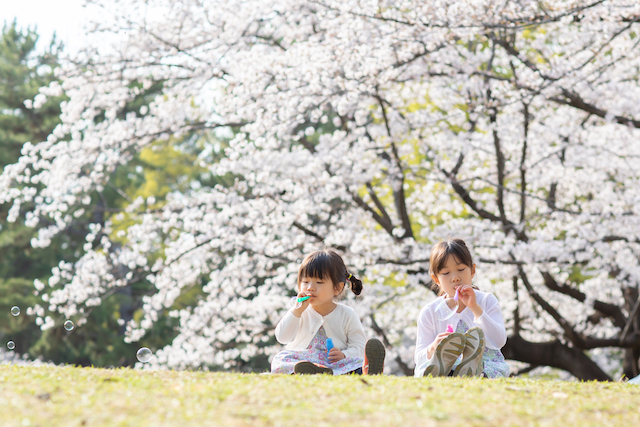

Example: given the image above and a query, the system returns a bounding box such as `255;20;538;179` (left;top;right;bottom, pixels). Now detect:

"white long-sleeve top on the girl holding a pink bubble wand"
415;289;507;366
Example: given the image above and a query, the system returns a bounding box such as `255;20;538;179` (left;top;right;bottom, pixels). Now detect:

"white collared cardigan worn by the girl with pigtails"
276;304;366;359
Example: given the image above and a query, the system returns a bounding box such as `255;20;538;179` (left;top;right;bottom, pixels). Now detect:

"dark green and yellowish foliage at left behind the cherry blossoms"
0;22;225;366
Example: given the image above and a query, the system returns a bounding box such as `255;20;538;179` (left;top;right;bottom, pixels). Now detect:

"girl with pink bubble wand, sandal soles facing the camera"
415;239;509;378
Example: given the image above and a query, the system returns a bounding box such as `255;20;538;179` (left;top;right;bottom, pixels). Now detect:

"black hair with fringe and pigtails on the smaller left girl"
298;249;362;295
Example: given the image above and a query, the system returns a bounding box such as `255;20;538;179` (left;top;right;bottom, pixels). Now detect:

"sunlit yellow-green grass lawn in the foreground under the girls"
0;365;640;427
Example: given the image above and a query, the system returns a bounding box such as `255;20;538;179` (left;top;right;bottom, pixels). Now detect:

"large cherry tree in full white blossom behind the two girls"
0;0;640;380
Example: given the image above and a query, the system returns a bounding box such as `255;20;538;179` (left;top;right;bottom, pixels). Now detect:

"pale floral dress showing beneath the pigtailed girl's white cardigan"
271;327;363;375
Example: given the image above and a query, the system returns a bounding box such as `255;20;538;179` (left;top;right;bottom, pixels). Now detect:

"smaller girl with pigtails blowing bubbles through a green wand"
271;249;385;375
